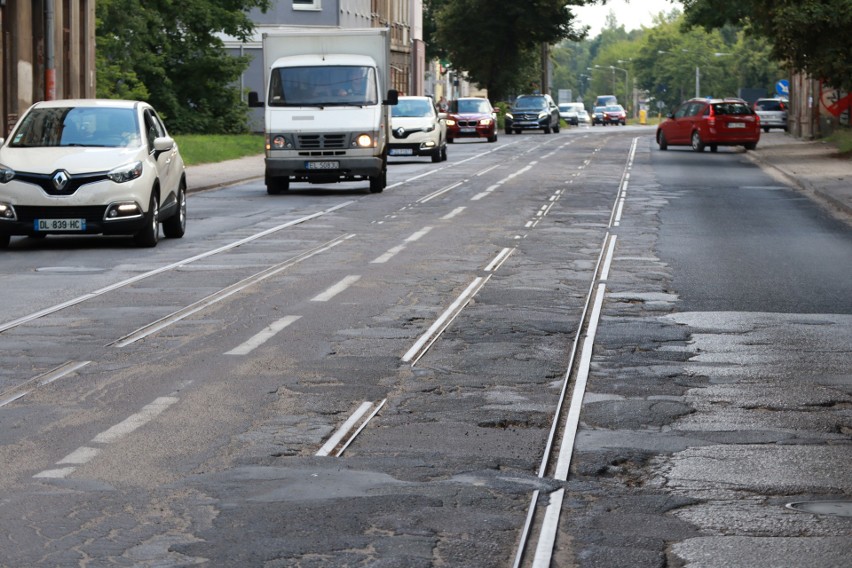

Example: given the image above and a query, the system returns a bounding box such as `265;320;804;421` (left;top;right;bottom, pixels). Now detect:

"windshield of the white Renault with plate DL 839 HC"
9;107;141;148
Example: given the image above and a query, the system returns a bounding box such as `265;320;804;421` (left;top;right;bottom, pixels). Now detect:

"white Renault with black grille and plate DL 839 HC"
0;99;186;248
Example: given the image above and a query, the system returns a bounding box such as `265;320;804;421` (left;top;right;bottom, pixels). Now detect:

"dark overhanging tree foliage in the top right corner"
683;0;852;91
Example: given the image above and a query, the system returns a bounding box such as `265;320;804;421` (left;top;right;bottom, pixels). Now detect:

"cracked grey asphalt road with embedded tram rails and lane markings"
0;127;852;567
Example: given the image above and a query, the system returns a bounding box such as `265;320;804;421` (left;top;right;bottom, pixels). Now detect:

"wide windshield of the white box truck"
268;66;379;106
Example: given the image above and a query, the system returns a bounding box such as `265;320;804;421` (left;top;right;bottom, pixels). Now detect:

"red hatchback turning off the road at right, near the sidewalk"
657;98;760;152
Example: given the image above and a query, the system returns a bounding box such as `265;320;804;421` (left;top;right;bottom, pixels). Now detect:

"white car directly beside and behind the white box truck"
388;96;447;162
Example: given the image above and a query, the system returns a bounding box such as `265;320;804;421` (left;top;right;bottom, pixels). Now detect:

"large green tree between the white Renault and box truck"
96;0;270;133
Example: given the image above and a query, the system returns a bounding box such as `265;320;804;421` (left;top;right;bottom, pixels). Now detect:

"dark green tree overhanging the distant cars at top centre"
430;0;585;100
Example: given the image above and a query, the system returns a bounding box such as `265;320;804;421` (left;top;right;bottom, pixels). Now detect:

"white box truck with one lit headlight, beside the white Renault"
262;28;398;195
